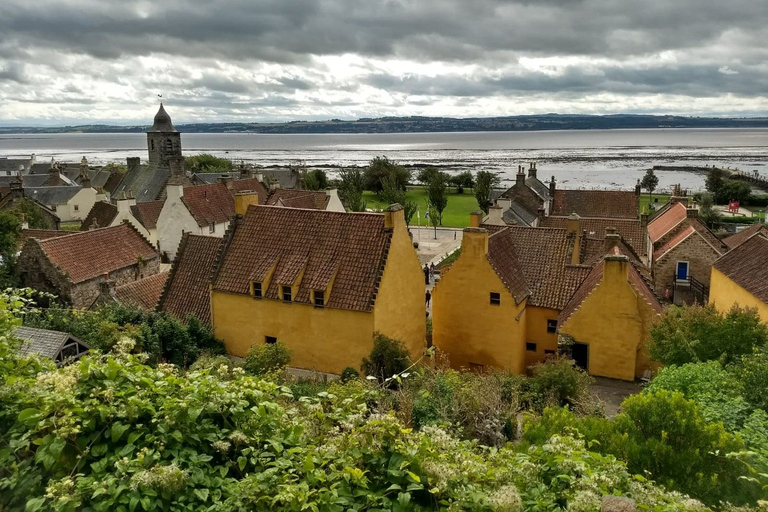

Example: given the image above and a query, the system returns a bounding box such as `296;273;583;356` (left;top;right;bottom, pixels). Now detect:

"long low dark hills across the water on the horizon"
0;114;768;134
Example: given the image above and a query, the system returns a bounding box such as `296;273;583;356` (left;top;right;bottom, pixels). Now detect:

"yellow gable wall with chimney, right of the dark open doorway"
560;260;657;380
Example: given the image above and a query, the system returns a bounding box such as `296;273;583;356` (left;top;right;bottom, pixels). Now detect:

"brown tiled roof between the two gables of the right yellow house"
504;226;590;309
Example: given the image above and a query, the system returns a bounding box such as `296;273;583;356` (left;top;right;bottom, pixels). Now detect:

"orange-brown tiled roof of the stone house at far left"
35;224;159;283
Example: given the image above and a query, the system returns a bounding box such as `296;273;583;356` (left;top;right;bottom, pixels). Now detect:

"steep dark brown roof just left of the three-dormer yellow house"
157;233;223;325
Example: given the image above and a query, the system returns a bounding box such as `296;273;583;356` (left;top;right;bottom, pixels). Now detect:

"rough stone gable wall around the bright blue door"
653;233;720;297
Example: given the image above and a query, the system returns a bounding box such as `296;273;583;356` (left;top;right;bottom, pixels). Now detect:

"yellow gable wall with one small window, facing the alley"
432;231;526;374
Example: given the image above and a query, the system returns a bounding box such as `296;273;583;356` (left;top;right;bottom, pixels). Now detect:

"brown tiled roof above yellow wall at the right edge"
712;233;768;303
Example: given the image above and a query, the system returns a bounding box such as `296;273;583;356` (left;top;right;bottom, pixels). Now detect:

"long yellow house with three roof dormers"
211;205;426;373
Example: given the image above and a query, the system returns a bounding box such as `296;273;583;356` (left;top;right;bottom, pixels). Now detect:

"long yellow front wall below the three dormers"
211;291;373;373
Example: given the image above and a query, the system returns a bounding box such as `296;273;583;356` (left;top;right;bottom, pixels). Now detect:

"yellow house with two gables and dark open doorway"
433;212;662;380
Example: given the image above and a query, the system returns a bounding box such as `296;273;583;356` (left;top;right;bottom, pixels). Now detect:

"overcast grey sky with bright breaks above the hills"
0;0;768;125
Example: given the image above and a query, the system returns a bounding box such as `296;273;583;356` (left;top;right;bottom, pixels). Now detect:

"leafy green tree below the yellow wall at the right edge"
648;304;768;365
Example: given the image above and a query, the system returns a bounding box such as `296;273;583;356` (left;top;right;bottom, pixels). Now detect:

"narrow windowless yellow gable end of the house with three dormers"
370;211;427;367
